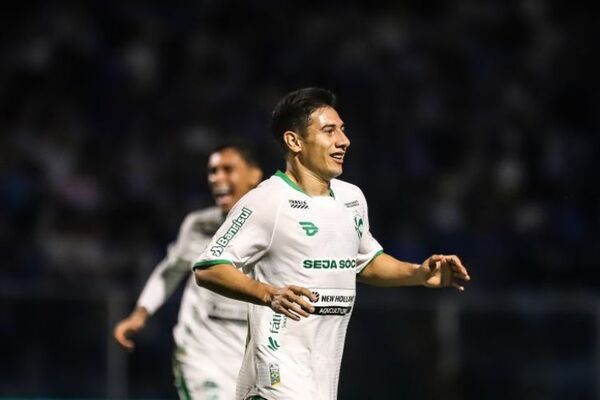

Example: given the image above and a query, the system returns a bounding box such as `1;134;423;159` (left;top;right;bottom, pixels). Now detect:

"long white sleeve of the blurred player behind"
137;214;209;315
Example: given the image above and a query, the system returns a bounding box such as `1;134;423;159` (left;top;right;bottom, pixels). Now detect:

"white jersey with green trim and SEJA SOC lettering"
194;171;382;400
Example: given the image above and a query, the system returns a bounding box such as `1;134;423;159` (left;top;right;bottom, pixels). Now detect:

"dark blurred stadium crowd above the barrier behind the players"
0;0;600;398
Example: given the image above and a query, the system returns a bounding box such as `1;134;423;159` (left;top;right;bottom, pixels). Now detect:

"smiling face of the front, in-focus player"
300;107;350;181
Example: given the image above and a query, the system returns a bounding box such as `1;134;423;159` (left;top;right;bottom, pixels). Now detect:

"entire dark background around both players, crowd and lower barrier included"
0;0;600;399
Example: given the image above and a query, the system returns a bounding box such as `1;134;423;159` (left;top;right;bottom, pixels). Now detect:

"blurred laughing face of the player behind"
208;148;262;212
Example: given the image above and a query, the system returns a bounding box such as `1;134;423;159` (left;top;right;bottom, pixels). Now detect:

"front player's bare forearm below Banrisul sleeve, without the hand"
194;264;275;306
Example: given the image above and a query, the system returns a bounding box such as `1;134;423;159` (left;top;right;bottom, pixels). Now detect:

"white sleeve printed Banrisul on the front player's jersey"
192;188;279;273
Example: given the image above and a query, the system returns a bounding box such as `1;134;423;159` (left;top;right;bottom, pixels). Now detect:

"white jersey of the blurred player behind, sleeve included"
137;207;248;390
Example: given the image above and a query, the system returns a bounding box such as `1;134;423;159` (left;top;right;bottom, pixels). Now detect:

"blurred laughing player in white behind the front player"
114;145;262;400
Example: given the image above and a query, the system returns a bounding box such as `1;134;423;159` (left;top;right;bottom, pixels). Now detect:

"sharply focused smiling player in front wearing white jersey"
193;88;469;400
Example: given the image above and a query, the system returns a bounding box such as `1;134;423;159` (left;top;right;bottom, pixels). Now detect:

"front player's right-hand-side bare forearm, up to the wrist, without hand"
358;254;424;287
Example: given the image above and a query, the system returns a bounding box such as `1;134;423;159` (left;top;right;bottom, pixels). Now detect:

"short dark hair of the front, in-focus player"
271;87;337;151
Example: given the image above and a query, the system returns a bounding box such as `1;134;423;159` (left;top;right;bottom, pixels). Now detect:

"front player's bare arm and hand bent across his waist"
194;264;317;321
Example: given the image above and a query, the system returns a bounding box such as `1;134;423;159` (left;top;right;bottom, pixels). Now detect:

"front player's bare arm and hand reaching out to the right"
358;254;470;291
